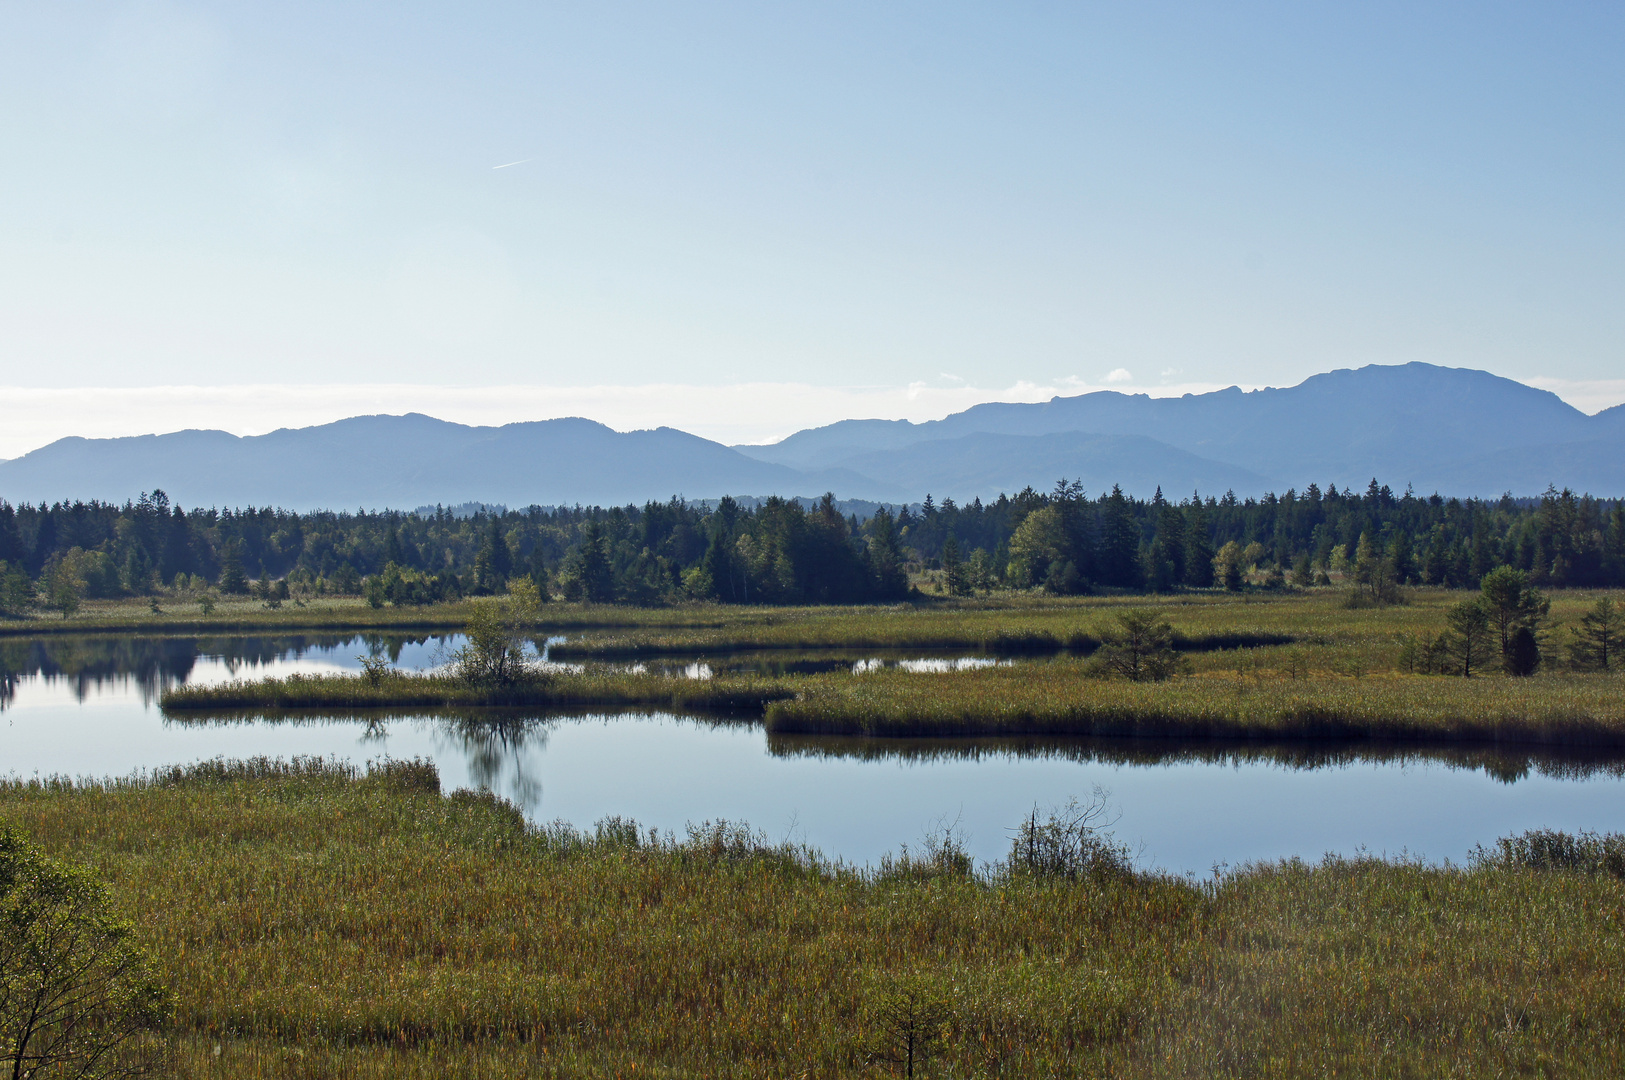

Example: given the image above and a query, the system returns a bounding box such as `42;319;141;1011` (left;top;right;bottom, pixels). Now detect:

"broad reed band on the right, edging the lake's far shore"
767;661;1625;747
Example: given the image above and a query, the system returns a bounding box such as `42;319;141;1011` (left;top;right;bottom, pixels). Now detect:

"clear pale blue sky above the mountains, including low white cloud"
0;0;1625;456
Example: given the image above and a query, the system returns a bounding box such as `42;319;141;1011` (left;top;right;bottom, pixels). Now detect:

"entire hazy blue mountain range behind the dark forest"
0;364;1625;510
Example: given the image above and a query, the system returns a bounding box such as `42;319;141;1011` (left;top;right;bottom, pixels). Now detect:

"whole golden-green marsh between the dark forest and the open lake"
163;575;1625;747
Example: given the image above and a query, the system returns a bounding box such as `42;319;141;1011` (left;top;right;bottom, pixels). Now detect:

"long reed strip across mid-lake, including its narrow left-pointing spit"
161;659;1625;749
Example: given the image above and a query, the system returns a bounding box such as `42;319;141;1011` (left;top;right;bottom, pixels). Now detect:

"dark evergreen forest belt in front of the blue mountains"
0;479;1625;614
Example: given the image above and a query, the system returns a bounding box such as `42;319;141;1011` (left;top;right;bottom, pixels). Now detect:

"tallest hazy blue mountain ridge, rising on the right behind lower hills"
738;364;1625;495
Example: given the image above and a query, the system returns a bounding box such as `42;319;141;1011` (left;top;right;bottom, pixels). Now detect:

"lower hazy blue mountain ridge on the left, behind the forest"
0;413;904;510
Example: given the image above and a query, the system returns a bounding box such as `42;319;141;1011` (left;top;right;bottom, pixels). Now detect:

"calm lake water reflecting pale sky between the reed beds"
0;635;1625;874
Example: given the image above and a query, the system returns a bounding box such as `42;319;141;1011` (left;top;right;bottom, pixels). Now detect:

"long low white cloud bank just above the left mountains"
0;380;1241;458
